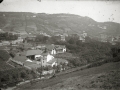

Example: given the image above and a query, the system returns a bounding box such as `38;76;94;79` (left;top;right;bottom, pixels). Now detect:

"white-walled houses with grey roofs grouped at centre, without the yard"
26;45;68;67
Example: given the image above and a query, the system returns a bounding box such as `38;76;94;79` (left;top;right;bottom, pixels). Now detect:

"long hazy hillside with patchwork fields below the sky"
0;12;120;38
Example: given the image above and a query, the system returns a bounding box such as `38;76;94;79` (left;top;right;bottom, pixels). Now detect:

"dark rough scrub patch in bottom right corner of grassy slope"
87;70;120;90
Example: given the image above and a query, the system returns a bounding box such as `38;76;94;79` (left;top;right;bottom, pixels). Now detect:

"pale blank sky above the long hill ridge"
0;0;120;23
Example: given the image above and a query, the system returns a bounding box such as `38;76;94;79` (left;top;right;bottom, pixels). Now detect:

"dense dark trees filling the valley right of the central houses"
62;38;112;66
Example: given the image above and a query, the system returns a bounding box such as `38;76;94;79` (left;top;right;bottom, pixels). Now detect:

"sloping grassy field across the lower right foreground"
15;62;120;90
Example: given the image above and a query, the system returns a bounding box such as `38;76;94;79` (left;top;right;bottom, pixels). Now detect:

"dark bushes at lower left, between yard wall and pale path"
0;68;37;87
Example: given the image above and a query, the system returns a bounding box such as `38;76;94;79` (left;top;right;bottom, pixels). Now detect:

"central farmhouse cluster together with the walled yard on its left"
13;44;68;74
